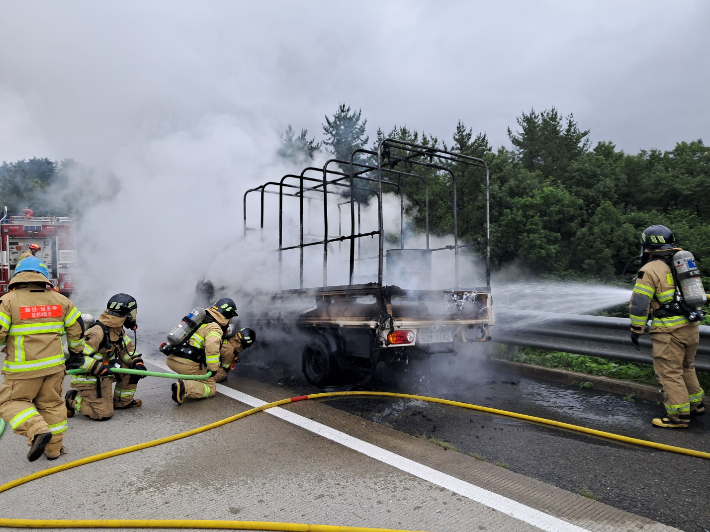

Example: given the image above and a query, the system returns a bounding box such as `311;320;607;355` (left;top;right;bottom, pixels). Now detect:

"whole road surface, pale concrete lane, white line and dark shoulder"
0;335;710;532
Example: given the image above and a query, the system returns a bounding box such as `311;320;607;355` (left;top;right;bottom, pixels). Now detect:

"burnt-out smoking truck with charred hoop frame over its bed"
244;138;494;387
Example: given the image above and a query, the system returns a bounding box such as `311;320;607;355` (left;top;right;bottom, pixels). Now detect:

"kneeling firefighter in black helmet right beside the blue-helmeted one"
64;294;146;421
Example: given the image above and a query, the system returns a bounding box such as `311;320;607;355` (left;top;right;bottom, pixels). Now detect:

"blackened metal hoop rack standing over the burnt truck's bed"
244;138;490;292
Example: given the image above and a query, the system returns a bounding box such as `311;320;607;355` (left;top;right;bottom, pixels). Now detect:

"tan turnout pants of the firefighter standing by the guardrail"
651;326;703;417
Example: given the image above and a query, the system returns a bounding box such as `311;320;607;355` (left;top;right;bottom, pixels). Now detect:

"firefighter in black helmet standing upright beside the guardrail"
629;225;705;428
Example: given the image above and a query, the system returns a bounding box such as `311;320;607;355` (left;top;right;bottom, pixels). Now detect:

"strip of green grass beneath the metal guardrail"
498;348;710;390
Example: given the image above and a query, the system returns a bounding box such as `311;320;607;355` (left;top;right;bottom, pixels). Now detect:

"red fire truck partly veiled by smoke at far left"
0;207;76;296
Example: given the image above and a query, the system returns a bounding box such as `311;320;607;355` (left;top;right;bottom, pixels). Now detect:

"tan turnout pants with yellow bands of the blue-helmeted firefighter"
0;370;67;458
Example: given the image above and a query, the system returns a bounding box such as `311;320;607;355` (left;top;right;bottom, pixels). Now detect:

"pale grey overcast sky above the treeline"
0;0;710;166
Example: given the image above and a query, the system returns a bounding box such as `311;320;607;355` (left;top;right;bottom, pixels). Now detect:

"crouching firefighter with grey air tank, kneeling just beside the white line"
166;297;237;404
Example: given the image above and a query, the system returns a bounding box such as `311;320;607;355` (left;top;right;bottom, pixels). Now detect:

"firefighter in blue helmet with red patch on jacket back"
0;257;96;462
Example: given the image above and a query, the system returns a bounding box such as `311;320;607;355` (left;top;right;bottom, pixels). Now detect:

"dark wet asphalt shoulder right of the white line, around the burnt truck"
229;340;710;532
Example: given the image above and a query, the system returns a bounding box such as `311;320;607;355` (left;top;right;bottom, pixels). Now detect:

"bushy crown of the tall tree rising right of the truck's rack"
508;107;589;182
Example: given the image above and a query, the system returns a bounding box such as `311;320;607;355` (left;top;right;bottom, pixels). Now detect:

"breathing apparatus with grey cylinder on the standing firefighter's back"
654;250;707;322
